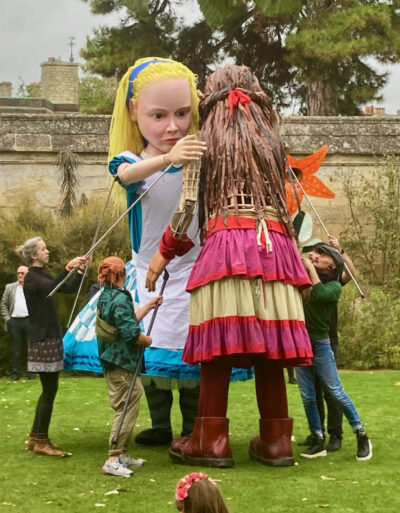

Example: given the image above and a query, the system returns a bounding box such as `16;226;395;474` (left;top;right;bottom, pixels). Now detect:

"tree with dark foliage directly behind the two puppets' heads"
81;0;296;106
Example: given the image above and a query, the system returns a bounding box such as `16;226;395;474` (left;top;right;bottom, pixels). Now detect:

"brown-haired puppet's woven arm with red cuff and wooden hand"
146;161;200;292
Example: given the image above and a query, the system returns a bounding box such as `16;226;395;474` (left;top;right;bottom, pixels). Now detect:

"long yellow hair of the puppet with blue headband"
108;57;199;161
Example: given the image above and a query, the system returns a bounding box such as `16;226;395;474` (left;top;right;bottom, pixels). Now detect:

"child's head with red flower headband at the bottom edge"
175;472;228;513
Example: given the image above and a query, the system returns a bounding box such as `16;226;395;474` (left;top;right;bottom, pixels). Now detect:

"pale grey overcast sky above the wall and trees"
0;0;400;114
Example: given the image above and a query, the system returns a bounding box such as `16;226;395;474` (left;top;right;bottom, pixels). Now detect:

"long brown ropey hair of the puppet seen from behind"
199;65;295;242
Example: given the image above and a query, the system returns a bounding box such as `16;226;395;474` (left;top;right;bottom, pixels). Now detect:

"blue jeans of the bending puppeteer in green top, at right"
296;339;362;436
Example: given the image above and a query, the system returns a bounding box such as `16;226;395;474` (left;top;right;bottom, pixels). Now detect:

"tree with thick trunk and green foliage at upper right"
199;0;400;115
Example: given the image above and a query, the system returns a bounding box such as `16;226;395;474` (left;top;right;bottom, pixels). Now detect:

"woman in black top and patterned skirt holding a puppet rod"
16;237;89;458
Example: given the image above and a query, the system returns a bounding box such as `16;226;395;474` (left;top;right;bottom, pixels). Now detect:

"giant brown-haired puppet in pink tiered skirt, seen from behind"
147;66;312;467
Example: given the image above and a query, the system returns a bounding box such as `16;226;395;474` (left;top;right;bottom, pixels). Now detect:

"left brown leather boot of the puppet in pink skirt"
169;417;234;467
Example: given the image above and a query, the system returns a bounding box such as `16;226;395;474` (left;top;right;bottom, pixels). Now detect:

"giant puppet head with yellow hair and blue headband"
109;57;198;160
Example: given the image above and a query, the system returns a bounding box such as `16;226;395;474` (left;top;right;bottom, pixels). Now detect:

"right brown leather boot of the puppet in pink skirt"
249;418;294;467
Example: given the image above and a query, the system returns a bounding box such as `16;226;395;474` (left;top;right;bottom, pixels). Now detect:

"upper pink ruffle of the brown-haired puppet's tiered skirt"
186;229;311;292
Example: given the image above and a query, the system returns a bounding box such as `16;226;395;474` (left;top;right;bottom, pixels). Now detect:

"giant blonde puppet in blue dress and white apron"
109;58;205;445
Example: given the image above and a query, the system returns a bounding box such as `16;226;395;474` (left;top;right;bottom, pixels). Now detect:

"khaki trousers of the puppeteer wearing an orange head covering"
105;367;143;456
